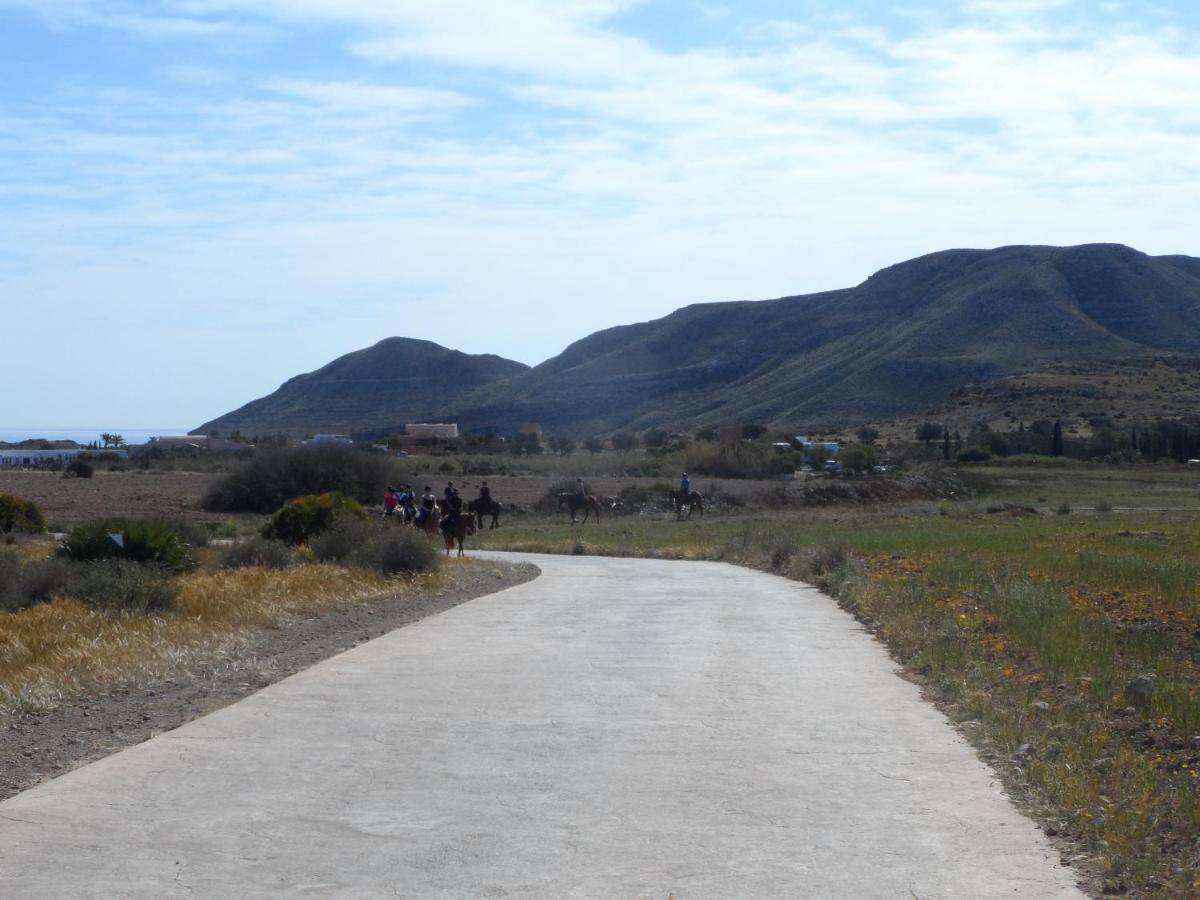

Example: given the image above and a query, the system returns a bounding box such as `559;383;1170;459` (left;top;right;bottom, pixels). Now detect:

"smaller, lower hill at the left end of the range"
196;337;529;436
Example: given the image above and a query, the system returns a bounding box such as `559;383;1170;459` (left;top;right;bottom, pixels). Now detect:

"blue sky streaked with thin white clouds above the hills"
0;0;1200;427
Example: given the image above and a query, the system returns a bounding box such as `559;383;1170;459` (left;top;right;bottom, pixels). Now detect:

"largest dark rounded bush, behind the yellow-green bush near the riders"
203;446;391;514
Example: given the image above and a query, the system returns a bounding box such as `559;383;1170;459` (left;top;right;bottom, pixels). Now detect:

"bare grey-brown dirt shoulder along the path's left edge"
0;562;538;799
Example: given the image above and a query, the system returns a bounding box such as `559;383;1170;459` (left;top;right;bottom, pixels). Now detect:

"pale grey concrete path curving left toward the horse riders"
0;557;1080;900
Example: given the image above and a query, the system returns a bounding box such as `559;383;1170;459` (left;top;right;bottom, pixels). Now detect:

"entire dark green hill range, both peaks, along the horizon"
196;245;1200;434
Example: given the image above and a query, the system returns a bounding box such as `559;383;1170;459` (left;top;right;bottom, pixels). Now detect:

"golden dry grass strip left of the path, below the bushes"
0;565;450;716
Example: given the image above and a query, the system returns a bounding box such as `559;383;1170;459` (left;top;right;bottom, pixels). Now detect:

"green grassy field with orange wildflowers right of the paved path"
472;462;1200;896
